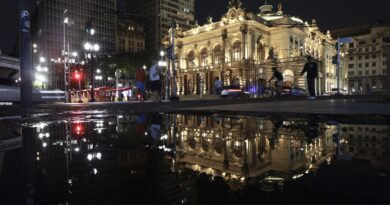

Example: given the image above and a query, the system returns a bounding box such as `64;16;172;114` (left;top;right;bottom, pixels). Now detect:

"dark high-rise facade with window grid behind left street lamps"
32;0;116;89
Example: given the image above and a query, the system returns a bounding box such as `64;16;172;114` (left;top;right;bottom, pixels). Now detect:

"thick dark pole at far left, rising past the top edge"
19;0;32;116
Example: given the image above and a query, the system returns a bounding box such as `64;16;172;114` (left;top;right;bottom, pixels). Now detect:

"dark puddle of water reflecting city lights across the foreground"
0;113;390;204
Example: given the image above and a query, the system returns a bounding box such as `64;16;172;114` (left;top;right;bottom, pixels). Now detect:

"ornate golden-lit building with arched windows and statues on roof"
175;0;336;95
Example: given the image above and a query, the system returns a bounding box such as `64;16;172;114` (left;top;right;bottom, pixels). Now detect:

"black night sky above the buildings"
0;0;390;53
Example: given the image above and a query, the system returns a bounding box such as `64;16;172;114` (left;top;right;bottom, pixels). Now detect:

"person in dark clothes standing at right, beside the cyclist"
301;56;318;100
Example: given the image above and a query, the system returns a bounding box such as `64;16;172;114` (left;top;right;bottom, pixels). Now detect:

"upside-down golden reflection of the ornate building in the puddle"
169;115;336;189
